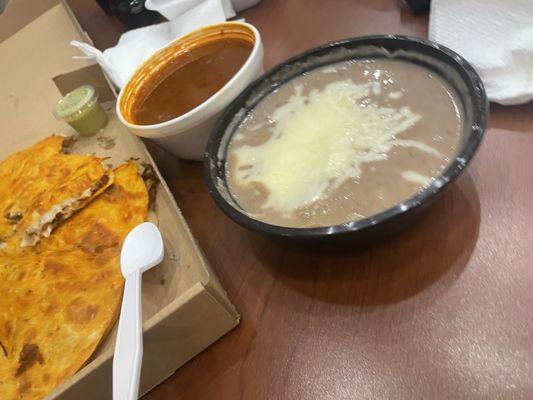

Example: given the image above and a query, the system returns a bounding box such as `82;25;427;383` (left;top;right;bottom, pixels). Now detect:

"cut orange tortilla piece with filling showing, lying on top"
0;136;113;253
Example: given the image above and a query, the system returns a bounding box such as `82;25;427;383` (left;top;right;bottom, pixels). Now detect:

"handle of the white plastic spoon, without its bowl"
113;271;143;400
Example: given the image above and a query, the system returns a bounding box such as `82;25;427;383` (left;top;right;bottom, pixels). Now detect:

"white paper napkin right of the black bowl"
429;0;533;105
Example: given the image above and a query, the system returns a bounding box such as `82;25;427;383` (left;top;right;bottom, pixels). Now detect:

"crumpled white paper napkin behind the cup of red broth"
70;0;235;88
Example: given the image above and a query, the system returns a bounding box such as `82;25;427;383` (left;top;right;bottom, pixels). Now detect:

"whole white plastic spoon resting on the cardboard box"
113;222;163;400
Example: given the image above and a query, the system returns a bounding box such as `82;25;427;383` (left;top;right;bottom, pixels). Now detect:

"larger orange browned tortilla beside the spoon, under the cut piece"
0;141;148;400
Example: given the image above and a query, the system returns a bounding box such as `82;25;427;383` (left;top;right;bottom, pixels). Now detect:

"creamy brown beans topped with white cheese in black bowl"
226;58;463;227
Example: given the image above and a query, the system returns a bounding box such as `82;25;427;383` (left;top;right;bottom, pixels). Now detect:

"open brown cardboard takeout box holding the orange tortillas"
0;0;239;400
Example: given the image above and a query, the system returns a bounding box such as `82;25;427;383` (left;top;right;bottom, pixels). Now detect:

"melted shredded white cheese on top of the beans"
235;79;440;214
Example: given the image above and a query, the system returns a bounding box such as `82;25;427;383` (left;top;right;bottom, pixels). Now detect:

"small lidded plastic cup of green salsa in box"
54;85;109;136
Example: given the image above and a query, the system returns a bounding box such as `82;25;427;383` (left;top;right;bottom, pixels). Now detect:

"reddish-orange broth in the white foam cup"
132;38;253;125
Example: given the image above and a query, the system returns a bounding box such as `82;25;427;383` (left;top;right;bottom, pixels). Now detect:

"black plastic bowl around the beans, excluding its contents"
204;35;489;245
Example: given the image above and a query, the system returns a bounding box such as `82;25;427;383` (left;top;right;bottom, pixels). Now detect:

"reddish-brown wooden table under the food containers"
69;0;533;400
